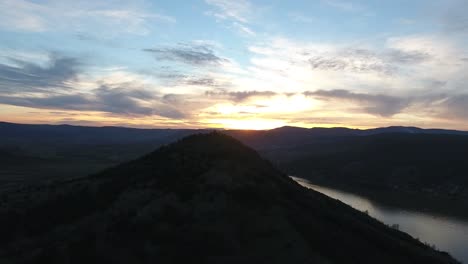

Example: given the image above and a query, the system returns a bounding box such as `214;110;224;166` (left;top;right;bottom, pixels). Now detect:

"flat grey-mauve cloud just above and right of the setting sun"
304;90;410;117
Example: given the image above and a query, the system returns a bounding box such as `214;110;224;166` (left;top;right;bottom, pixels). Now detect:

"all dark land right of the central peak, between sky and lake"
228;127;468;217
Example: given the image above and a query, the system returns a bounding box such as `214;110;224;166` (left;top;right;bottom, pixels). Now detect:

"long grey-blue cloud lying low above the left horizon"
0;85;185;118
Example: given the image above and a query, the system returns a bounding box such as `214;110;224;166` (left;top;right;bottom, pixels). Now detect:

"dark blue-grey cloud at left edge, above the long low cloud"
0;54;81;92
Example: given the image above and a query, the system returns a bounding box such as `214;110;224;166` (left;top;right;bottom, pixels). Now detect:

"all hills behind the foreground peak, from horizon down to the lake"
0;120;468;217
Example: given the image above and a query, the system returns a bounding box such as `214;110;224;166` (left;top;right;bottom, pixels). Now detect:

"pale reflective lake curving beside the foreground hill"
291;177;468;264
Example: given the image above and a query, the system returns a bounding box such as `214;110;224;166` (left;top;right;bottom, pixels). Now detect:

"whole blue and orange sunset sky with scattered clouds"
0;0;468;130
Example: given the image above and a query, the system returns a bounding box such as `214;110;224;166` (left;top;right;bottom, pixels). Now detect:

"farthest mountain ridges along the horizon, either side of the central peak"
0;122;468;144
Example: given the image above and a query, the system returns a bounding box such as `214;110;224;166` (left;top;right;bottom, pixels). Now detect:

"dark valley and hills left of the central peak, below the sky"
0;122;203;187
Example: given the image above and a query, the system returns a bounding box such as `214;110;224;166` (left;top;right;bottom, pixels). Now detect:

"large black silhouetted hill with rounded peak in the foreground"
0;133;456;264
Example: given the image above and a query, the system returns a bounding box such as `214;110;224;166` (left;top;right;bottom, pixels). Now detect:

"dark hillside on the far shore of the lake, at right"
284;133;468;218
